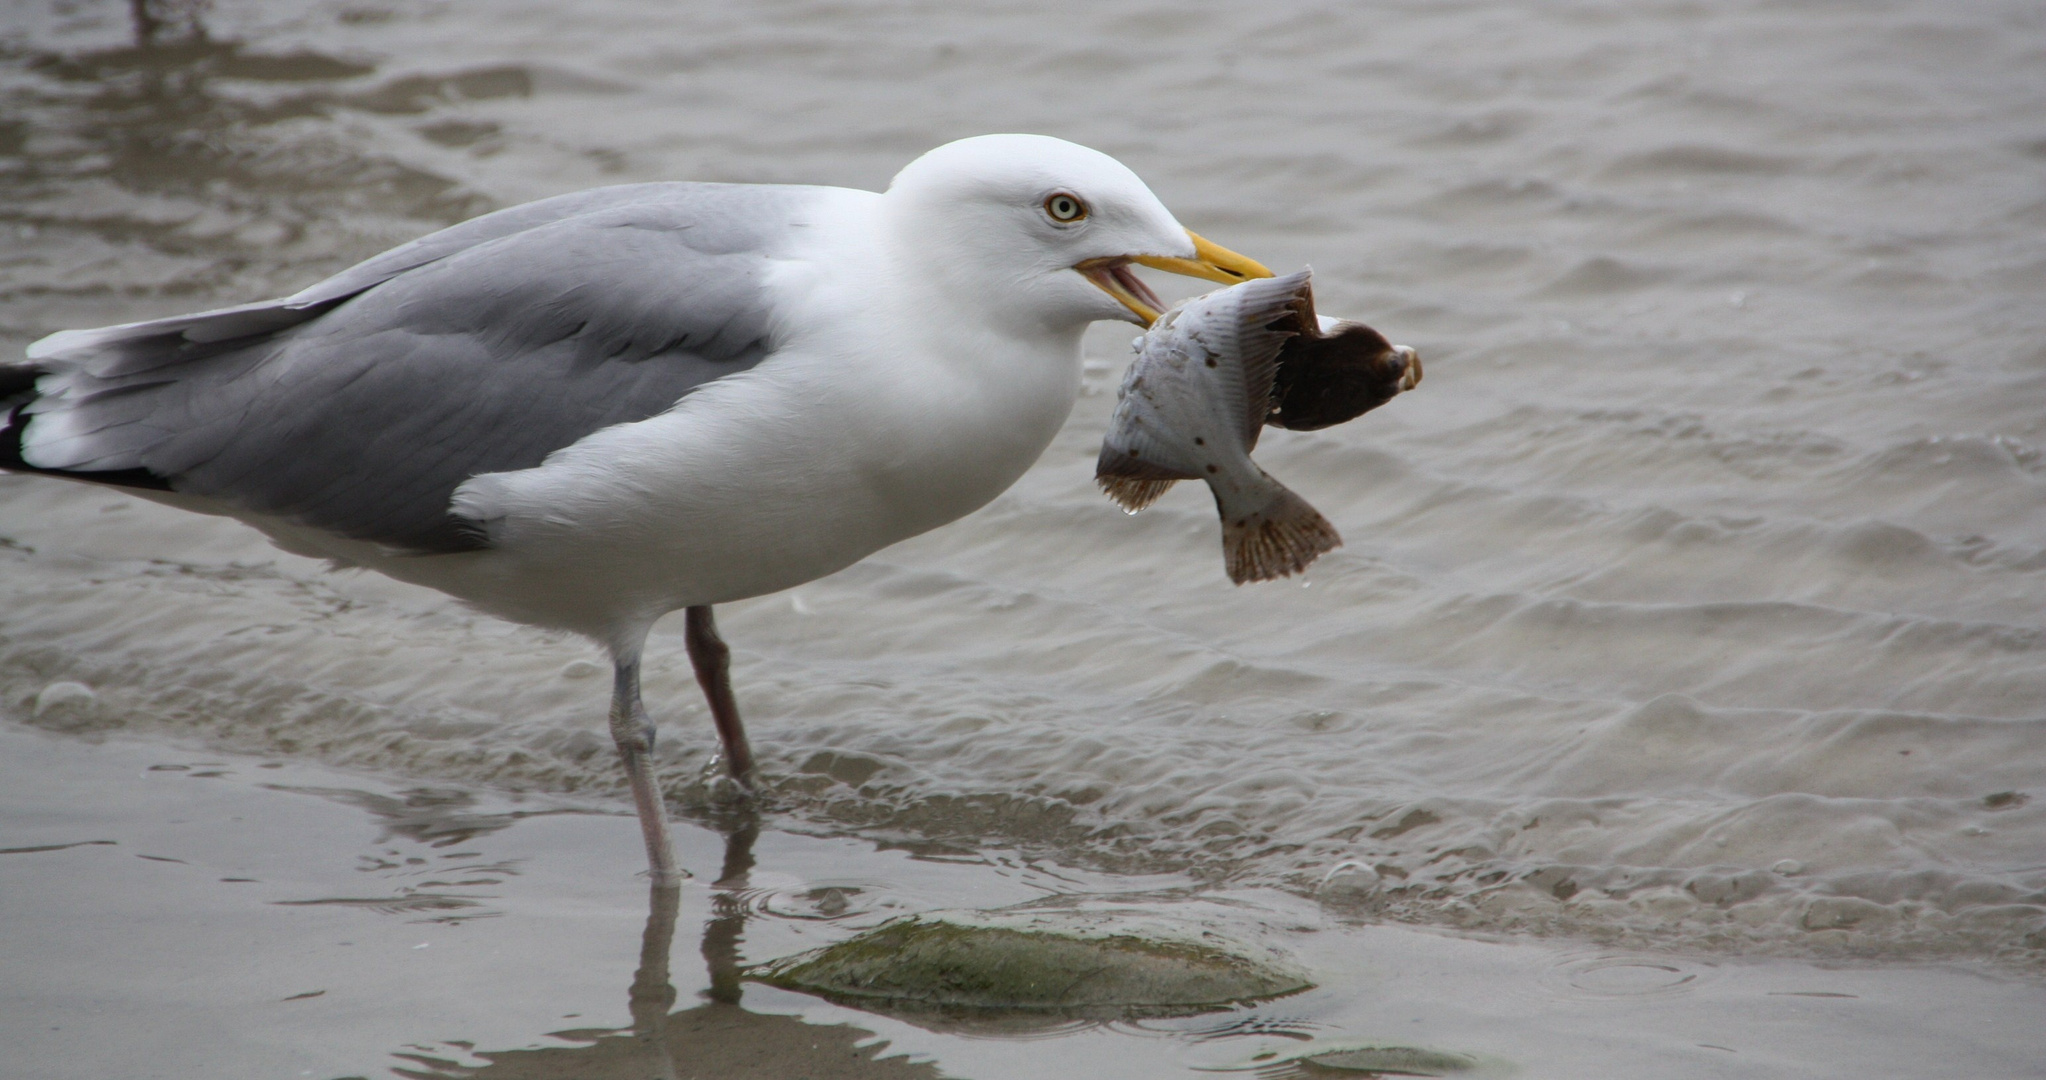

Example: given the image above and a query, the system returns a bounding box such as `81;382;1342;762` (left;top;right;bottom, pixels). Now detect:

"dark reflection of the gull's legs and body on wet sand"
391;814;939;1080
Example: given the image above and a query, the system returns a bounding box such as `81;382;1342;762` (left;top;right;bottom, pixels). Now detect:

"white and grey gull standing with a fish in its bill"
0;135;1271;886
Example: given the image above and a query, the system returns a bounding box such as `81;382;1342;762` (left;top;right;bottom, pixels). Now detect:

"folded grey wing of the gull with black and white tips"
0;184;816;552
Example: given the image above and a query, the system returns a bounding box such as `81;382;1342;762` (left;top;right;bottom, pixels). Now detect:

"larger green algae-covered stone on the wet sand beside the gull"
749;912;1314;1015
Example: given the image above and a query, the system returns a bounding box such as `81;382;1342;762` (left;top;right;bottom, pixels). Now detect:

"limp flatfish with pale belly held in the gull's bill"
1095;270;1420;585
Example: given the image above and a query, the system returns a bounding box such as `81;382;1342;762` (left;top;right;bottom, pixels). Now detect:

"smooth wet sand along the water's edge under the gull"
0;726;2046;1080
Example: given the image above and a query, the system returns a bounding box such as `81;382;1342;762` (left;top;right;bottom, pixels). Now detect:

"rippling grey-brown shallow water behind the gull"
0;0;2046;990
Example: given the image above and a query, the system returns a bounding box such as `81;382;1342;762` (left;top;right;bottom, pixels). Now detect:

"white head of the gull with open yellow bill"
884;135;1271;331
